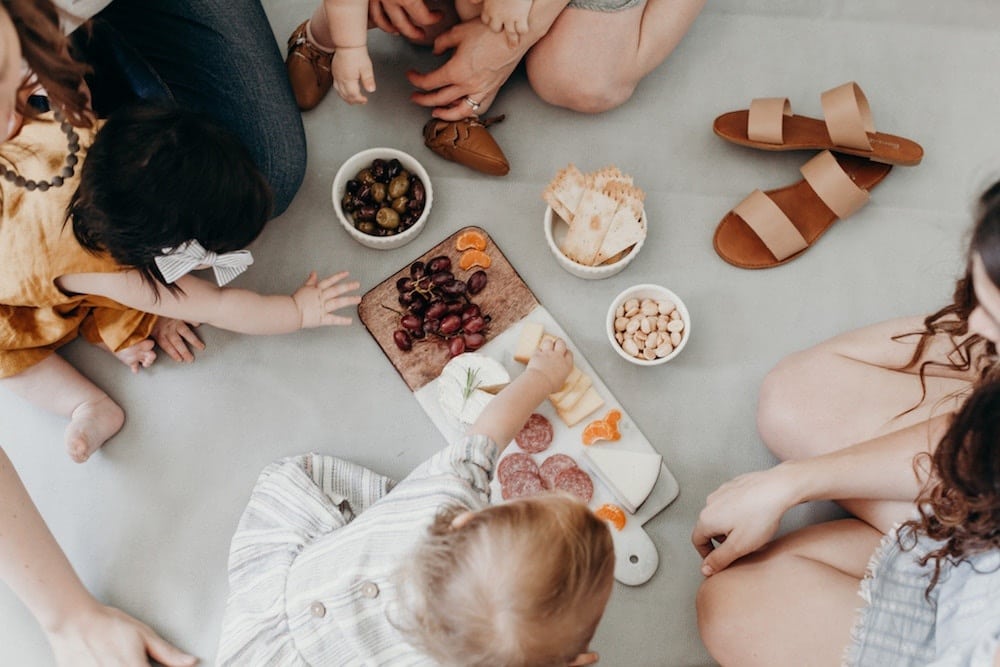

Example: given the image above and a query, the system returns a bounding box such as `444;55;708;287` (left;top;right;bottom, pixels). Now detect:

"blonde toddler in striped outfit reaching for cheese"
218;341;614;667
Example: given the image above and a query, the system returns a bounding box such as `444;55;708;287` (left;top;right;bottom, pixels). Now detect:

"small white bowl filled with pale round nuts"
607;284;691;366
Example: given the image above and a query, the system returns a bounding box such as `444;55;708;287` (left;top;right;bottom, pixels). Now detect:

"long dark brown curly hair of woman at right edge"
899;181;1000;595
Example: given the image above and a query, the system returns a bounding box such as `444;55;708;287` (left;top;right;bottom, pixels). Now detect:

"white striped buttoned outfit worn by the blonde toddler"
218;436;498;667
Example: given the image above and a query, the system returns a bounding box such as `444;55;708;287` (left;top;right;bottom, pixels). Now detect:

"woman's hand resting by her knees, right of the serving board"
691;464;798;577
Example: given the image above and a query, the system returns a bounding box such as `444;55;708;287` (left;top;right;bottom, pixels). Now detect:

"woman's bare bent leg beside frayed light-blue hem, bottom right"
697;519;882;667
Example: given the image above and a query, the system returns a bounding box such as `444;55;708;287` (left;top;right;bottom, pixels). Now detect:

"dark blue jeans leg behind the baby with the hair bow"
88;0;306;215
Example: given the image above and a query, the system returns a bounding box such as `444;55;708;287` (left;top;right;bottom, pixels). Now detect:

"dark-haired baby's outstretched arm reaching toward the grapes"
56;271;361;334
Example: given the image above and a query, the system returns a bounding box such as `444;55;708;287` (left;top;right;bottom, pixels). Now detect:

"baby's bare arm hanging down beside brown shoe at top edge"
323;0;375;104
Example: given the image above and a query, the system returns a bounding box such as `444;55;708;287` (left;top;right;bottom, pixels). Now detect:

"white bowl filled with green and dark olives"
332;148;433;250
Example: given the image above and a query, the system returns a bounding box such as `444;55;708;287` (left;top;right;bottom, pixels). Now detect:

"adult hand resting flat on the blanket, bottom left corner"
48;600;198;667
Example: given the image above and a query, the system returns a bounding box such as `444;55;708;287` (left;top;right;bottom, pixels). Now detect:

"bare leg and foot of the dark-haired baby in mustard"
0;354;125;463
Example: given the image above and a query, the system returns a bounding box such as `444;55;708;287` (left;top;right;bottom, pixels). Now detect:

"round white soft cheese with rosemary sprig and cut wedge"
438;352;510;424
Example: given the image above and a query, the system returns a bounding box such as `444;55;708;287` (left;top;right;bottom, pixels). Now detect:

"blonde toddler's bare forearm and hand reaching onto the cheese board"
469;339;573;451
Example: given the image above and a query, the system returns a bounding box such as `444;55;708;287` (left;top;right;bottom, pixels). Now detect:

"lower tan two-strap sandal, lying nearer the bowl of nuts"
713;151;892;269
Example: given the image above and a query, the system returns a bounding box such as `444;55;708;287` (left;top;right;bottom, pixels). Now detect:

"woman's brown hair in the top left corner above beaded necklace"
0;0;94;127
